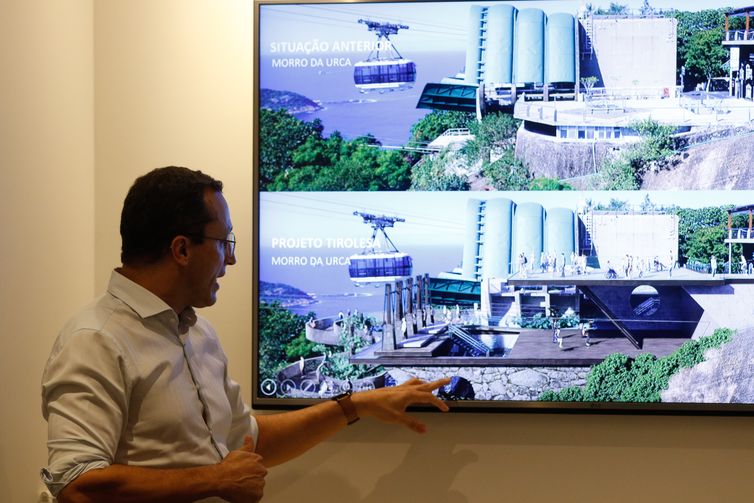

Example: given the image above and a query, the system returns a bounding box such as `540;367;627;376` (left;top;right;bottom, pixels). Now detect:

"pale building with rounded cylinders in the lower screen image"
461;198;678;281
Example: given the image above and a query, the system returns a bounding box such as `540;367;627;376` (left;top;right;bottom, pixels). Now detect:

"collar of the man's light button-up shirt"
107;270;196;335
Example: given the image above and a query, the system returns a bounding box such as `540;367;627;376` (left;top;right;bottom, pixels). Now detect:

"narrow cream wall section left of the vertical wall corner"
0;0;95;503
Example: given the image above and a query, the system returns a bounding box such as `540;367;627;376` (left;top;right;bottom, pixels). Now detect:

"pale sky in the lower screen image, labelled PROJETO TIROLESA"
259;190;754;248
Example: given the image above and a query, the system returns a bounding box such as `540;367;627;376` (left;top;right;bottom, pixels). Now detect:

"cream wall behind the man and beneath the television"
0;0;754;503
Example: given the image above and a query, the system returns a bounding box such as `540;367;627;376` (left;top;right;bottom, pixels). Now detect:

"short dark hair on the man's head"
120;166;223;264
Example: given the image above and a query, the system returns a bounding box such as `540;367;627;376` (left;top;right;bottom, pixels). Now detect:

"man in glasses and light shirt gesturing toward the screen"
42;167;449;503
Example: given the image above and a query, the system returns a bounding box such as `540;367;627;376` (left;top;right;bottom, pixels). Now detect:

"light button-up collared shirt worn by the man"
42;271;258;495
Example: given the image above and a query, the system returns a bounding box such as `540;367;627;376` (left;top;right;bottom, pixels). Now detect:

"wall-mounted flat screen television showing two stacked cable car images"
252;0;754;414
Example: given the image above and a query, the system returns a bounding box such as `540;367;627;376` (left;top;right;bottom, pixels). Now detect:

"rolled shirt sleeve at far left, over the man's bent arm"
41;329;130;496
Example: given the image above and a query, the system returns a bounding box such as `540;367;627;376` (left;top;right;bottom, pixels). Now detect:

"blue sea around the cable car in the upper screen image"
259;52;465;145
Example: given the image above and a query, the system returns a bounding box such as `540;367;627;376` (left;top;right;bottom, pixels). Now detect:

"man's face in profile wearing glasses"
189;190;236;307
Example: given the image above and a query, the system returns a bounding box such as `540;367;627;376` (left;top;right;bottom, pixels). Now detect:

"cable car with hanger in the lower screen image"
348;211;413;286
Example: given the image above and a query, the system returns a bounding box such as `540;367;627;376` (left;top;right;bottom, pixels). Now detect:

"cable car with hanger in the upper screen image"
353;19;416;93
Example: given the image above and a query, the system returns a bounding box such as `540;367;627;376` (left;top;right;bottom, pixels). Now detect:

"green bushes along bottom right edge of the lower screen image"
539;328;735;402
